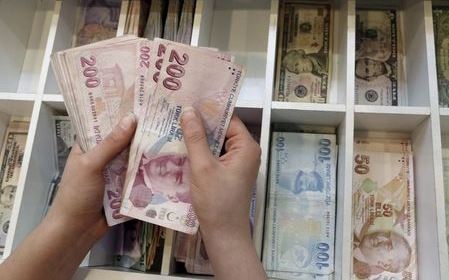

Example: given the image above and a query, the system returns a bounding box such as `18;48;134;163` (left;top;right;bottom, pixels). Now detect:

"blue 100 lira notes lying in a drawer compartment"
263;132;337;280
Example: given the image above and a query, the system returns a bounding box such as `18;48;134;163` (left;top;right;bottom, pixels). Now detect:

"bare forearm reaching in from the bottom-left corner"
0;212;97;280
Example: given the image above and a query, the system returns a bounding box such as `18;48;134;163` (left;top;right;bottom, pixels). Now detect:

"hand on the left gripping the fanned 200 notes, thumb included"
48;114;136;239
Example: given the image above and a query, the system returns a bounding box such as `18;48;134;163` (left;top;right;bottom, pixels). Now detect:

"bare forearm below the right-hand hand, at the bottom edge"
202;226;266;280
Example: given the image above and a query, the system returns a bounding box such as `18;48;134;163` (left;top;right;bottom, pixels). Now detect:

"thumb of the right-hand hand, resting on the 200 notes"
181;107;214;167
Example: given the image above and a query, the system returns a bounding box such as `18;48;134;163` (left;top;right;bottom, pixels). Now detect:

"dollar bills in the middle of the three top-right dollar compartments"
355;10;407;106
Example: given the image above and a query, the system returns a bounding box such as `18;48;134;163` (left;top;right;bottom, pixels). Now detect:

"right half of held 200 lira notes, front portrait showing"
120;40;244;234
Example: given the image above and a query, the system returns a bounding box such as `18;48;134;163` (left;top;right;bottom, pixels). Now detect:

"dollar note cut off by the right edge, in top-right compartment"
433;7;449;107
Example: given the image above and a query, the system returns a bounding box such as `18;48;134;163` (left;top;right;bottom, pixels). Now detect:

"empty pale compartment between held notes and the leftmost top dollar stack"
206;1;270;105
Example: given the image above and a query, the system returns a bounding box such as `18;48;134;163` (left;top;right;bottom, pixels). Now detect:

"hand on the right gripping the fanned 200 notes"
181;109;261;242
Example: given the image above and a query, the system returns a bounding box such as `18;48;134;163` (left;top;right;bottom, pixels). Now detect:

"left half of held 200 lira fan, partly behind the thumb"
52;36;148;225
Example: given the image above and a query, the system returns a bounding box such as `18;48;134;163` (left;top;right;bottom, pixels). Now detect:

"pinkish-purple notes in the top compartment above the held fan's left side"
72;0;122;47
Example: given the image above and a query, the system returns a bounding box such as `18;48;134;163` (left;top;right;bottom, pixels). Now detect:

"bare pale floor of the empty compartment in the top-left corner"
0;0;38;92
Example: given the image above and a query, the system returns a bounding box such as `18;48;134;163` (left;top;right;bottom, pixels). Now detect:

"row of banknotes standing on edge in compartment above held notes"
125;0;195;44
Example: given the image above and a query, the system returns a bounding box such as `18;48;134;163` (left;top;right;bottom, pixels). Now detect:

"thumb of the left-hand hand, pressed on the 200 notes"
85;113;136;169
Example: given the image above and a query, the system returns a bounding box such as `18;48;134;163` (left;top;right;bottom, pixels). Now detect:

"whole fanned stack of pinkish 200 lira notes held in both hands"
52;36;243;234
